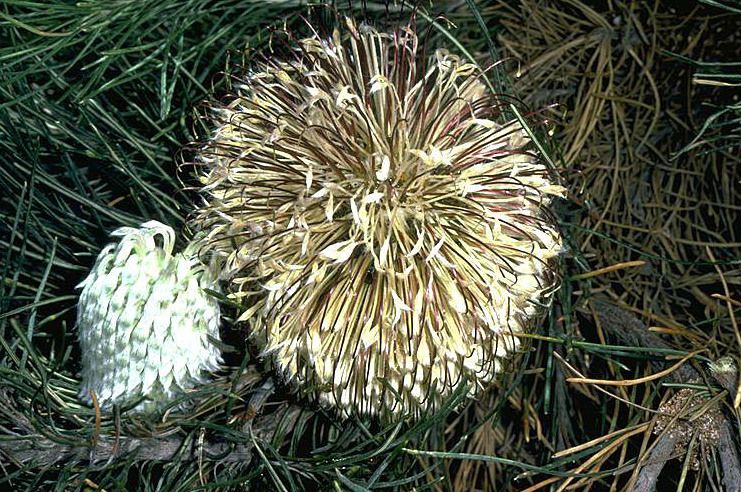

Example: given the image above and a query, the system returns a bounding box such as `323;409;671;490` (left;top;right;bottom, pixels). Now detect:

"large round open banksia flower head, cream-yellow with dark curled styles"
193;20;562;415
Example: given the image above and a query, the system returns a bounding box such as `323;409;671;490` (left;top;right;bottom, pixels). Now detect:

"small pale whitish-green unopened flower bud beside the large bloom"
77;221;221;411
